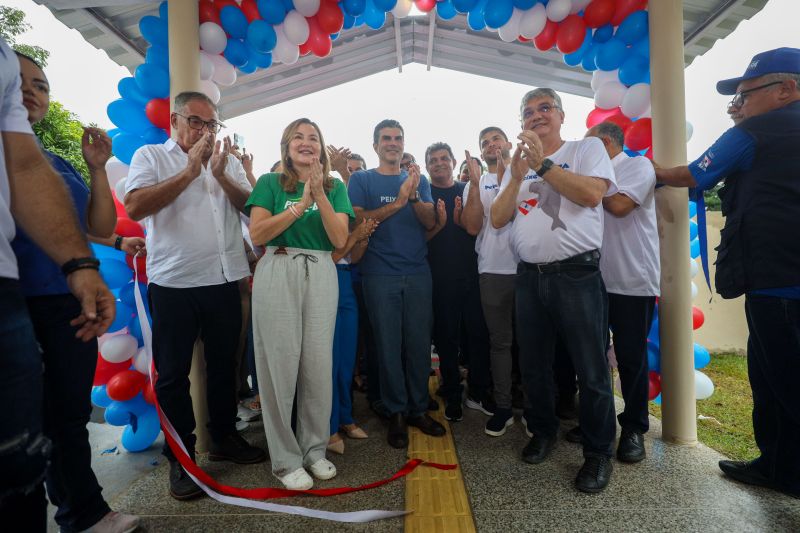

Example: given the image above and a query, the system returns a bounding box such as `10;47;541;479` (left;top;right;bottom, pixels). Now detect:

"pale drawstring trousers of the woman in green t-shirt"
253;246;339;476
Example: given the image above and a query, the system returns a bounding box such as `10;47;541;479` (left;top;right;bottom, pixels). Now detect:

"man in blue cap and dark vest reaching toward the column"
656;48;800;498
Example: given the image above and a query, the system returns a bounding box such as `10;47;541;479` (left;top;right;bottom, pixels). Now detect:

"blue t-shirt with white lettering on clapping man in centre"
347;169;433;276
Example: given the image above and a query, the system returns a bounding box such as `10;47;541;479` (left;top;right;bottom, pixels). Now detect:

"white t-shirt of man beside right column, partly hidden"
600;152;661;296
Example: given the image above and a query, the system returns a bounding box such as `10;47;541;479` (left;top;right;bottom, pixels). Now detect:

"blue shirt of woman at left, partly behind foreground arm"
11;152;89;297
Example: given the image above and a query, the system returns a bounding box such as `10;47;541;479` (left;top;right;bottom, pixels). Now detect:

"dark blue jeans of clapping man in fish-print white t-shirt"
515;264;616;457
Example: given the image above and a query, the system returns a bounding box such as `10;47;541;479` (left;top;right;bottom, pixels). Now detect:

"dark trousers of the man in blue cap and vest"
745;294;800;493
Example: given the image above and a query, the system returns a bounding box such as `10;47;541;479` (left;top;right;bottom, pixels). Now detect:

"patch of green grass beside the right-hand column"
650;354;759;461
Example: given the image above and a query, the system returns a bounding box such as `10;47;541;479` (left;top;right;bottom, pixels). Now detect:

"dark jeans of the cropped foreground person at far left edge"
0;278;49;531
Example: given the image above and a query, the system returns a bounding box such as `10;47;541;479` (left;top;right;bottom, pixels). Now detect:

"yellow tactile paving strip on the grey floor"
405;377;475;533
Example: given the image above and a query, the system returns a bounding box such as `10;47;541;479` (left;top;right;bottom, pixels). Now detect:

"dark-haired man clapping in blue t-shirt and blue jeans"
348;119;445;448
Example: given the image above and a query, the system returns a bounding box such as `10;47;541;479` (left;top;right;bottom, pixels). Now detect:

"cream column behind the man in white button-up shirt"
167;0;208;453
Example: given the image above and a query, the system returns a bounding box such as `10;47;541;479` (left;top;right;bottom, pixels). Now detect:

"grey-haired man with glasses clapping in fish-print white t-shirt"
491;88;617;492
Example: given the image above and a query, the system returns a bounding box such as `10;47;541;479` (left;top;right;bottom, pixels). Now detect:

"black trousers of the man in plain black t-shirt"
433;275;492;402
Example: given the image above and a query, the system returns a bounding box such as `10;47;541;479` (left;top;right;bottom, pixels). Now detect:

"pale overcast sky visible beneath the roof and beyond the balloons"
7;0;800;173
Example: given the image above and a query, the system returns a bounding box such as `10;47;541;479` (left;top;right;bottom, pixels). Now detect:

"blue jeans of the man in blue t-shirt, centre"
363;272;433;416
